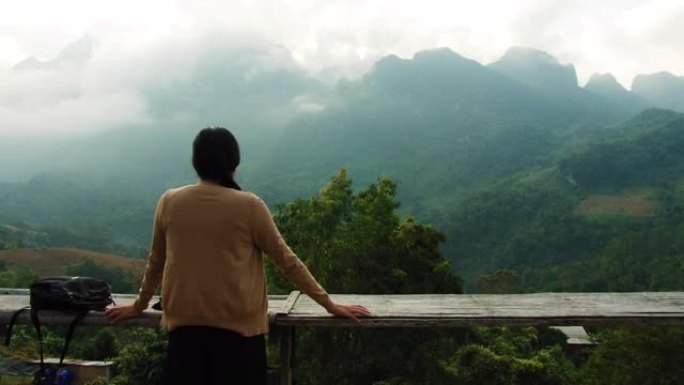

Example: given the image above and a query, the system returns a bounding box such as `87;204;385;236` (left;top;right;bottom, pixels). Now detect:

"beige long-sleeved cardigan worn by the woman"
134;182;331;336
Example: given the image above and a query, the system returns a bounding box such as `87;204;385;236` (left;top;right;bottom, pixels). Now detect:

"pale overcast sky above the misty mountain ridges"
0;0;684;134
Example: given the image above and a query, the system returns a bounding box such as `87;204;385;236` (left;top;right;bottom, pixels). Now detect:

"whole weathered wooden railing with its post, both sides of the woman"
0;289;684;385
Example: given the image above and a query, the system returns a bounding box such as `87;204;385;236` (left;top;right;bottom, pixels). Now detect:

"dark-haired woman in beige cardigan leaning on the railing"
107;127;370;385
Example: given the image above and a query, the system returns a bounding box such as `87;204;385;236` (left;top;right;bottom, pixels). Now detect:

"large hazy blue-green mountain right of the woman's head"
257;49;639;213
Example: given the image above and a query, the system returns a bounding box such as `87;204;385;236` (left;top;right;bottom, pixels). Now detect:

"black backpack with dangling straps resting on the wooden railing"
5;277;114;385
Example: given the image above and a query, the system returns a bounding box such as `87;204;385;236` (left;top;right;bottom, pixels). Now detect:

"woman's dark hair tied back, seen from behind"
192;127;242;190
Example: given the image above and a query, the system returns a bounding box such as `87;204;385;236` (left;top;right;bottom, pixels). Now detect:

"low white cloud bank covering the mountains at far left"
0;37;147;139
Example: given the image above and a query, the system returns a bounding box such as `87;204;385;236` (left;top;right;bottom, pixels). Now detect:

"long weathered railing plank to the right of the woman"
278;292;684;327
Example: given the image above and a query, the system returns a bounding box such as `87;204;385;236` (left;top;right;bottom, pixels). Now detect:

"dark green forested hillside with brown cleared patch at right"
446;110;684;291
